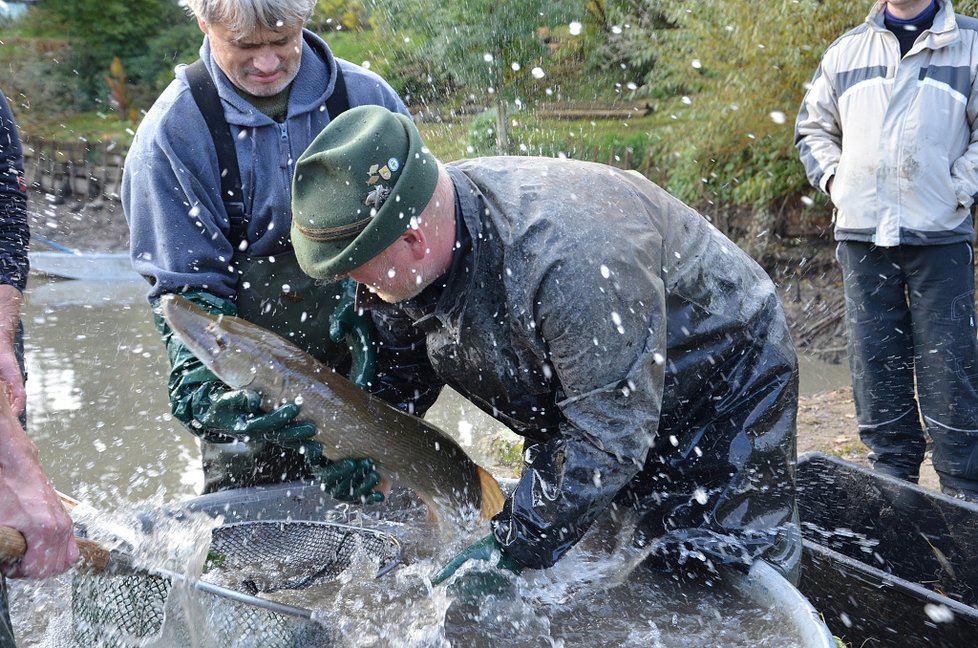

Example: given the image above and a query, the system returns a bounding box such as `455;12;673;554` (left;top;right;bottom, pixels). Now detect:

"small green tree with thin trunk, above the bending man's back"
376;0;583;153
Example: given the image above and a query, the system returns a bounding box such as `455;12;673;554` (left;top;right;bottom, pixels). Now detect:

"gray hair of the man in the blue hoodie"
187;0;316;34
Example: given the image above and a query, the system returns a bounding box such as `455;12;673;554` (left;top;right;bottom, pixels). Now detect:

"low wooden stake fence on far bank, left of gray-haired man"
24;138;126;200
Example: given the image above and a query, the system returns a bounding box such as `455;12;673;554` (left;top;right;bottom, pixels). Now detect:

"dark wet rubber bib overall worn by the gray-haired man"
187;54;350;493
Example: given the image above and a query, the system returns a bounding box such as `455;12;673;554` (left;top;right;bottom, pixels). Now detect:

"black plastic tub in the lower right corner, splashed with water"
798;453;978;648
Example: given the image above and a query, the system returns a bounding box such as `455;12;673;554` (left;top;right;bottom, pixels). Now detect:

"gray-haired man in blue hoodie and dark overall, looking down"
122;0;409;501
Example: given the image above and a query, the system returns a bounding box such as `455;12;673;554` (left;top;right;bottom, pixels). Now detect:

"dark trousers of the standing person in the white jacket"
836;241;978;494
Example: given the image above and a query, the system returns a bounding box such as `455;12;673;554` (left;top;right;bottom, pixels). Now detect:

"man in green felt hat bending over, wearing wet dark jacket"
292;107;801;583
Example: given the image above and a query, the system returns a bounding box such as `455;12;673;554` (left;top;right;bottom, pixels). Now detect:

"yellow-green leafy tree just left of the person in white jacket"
592;0;870;251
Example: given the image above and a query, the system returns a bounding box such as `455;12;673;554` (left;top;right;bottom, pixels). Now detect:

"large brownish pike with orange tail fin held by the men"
160;294;505;519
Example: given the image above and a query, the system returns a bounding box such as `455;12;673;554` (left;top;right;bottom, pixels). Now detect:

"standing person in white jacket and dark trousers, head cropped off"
795;0;978;501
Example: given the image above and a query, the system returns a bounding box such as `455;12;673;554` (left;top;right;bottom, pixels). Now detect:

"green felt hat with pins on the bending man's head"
292;106;438;280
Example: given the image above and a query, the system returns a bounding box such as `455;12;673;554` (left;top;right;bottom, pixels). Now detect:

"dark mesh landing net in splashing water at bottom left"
72;520;401;648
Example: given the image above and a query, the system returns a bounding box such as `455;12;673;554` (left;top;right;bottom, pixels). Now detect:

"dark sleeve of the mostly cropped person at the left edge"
0;93;30;290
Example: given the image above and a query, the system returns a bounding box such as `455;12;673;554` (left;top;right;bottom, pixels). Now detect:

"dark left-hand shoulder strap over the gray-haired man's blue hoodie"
186;59;245;235
